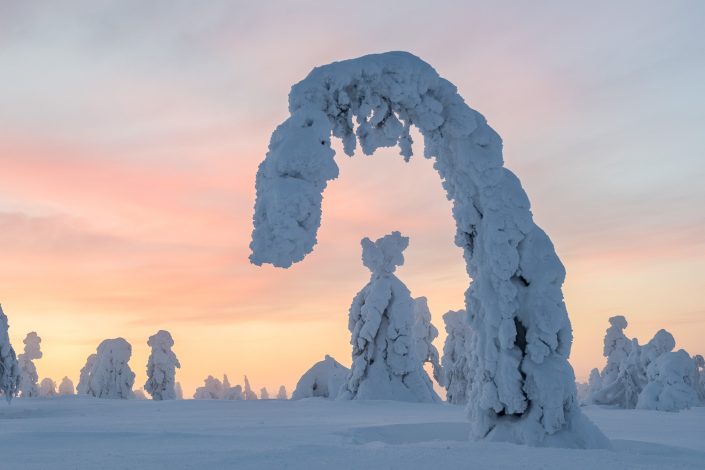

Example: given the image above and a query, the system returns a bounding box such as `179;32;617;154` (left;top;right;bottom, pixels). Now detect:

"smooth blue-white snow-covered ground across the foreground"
0;396;705;470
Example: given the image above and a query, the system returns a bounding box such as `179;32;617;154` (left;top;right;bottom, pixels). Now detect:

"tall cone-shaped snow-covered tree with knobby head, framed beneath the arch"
339;232;440;402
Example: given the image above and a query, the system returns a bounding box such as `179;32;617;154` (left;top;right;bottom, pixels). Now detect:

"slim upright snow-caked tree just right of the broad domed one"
144;330;181;400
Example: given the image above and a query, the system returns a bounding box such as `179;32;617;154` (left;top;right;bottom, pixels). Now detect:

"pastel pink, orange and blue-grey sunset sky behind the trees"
0;2;705;393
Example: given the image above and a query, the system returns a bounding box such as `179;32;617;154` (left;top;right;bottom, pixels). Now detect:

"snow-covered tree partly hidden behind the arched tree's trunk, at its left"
443;310;473;405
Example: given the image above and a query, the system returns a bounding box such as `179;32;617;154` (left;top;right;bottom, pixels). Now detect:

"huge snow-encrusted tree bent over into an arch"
250;52;608;447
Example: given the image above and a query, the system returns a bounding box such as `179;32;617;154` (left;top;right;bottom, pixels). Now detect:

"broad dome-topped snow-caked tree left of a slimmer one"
87;338;135;399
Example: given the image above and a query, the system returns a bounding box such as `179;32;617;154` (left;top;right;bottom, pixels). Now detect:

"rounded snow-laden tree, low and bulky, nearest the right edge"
636;349;700;411
